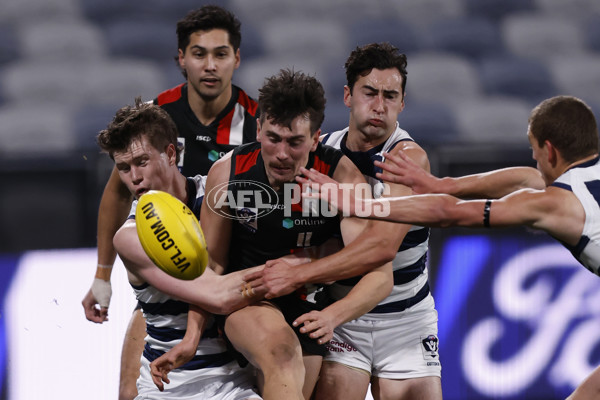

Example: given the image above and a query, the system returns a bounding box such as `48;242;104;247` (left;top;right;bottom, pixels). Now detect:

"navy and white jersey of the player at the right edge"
551;157;600;275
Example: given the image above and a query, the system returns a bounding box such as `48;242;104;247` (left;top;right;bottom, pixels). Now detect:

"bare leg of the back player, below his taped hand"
119;309;146;400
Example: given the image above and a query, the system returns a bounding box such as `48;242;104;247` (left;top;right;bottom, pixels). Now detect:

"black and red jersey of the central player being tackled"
229;143;342;271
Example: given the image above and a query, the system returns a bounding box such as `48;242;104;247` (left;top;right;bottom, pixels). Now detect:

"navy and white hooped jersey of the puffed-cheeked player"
322;123;430;314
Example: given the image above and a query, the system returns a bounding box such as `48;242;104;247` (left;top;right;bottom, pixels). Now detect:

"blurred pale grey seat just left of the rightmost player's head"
452;97;531;144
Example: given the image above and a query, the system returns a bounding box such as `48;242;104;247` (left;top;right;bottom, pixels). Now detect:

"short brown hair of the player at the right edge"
529;96;598;163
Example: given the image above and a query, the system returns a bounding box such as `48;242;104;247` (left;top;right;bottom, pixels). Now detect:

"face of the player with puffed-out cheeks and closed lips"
344;68;404;141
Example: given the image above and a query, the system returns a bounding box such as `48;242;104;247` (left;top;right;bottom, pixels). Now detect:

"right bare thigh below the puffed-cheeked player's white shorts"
371;376;442;400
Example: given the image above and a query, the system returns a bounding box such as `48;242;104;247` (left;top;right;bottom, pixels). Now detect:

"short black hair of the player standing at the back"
175;5;242;78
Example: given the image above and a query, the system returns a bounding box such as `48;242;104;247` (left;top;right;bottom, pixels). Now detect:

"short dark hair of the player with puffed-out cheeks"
344;42;407;96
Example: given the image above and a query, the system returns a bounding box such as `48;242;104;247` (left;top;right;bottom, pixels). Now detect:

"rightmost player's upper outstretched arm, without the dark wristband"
375;151;545;199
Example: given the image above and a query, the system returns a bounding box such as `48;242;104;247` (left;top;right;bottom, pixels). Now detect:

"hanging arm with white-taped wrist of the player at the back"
81;168;132;323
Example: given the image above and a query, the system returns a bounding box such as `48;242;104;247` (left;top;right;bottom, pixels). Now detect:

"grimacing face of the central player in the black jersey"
257;116;321;190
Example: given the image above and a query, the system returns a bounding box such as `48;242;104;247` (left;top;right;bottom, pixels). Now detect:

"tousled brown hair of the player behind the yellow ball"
96;97;183;162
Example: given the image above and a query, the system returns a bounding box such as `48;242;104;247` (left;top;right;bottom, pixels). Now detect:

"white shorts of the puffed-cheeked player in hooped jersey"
324;295;442;379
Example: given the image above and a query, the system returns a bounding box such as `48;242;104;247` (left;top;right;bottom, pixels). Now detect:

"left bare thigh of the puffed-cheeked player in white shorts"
315;361;371;400
